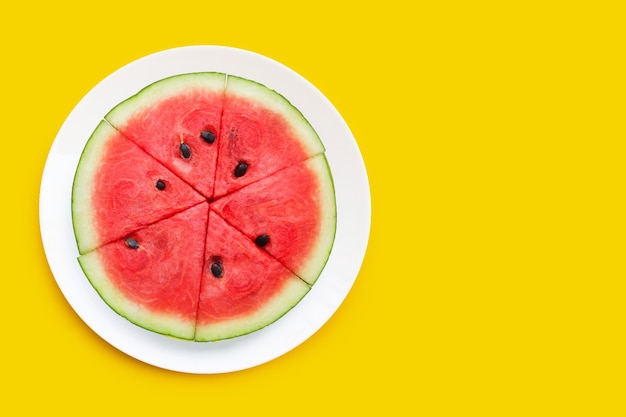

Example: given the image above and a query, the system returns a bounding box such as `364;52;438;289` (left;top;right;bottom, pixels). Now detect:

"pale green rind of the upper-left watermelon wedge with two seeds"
104;72;226;133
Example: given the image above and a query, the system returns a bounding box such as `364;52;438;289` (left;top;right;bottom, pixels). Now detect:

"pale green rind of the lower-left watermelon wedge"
78;251;195;340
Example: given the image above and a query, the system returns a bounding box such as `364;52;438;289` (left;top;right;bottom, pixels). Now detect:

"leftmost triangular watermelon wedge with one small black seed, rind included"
72;121;206;254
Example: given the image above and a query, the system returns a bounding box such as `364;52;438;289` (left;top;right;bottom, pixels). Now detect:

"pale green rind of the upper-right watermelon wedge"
226;74;326;157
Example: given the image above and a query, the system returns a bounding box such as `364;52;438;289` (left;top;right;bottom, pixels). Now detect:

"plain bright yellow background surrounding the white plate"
0;0;626;416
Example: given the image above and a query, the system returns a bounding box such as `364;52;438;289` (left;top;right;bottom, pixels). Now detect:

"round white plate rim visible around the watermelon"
39;46;371;374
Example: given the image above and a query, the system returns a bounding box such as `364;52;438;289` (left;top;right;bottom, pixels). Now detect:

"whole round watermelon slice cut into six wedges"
72;73;336;342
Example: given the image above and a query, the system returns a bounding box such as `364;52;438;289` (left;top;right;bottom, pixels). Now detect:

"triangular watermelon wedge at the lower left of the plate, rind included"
78;202;208;339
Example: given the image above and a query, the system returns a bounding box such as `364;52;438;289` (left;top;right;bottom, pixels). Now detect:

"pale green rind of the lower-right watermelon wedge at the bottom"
194;275;311;342
